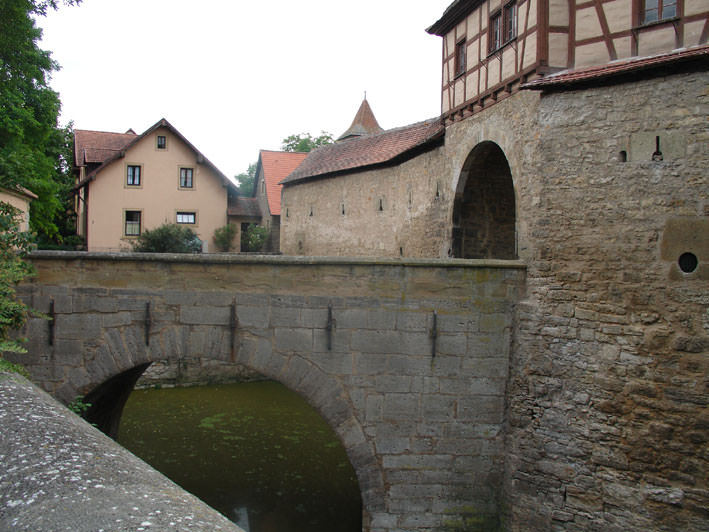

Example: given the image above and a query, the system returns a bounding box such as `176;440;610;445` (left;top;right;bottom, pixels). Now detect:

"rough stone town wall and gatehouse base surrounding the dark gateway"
283;69;709;532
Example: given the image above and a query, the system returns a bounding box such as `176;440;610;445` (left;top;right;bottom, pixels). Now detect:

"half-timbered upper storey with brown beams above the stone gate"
428;0;709;123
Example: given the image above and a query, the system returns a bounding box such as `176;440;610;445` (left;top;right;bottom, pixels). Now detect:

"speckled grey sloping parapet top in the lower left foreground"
0;373;244;532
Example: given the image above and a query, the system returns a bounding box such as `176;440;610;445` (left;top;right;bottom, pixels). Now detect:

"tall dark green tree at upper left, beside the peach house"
0;0;80;243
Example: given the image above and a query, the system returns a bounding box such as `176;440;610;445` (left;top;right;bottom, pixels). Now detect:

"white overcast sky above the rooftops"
37;0;452;181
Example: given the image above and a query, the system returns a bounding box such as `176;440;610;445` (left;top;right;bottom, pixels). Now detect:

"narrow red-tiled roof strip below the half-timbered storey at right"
522;45;709;89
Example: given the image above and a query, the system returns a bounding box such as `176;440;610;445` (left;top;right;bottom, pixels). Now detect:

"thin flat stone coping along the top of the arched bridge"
30;250;527;269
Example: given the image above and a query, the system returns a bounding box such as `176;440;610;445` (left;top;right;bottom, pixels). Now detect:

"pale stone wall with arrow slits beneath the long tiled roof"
281;148;453;257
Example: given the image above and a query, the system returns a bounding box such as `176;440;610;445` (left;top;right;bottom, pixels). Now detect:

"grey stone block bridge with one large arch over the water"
12;252;526;532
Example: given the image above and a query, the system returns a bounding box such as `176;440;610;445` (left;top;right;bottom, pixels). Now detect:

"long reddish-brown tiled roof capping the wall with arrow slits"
281;118;445;185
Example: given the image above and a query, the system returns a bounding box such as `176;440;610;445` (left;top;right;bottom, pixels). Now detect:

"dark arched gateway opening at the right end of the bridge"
451;141;517;259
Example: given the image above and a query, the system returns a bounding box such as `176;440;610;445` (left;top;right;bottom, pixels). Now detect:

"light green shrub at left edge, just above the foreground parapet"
0;202;33;353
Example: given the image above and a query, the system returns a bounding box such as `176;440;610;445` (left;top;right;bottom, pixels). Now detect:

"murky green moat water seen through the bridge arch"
118;382;362;532
